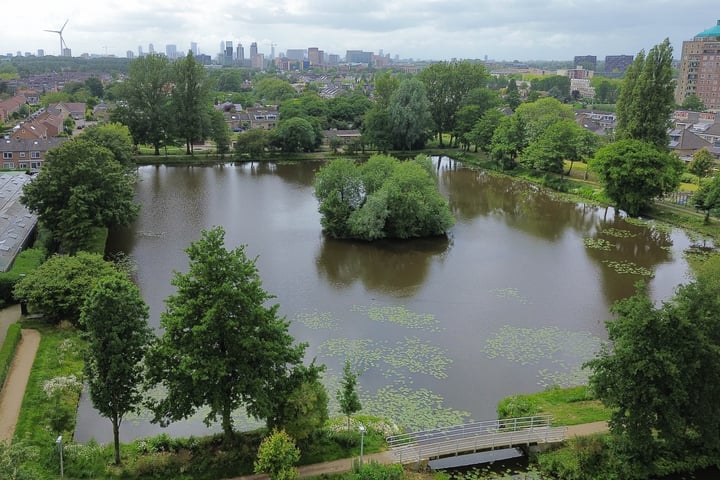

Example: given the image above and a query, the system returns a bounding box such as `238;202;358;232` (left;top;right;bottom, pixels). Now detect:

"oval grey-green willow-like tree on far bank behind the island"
388;79;432;150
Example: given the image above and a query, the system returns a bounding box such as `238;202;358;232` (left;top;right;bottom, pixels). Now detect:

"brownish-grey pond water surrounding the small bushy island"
75;158;702;442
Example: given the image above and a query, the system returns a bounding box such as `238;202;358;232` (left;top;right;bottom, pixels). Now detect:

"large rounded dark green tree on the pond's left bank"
20;139;139;253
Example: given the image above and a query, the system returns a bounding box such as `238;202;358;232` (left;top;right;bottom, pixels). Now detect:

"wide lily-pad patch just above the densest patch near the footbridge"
318;337;452;378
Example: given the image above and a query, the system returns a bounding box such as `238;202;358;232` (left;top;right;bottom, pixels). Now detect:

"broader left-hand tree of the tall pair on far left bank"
113;54;171;155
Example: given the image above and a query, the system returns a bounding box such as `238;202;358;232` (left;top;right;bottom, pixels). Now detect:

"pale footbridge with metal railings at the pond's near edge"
387;416;567;464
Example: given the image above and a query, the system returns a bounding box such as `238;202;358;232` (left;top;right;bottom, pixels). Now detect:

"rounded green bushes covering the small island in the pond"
315;155;453;240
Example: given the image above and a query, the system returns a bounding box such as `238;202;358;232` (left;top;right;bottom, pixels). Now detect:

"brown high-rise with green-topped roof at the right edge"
675;20;720;111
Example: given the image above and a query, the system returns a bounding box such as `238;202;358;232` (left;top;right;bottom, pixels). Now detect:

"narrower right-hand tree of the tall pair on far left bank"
171;52;210;155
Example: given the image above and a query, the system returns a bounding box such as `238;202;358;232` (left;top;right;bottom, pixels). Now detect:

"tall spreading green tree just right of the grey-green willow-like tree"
418;62;489;146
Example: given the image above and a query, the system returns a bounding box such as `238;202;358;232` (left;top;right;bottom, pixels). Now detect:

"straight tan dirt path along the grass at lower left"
0;330;40;442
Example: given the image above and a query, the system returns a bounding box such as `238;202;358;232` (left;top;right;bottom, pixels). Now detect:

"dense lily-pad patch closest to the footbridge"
361;385;472;431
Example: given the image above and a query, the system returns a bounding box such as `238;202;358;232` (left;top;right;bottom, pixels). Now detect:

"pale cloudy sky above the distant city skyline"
0;0;720;61
